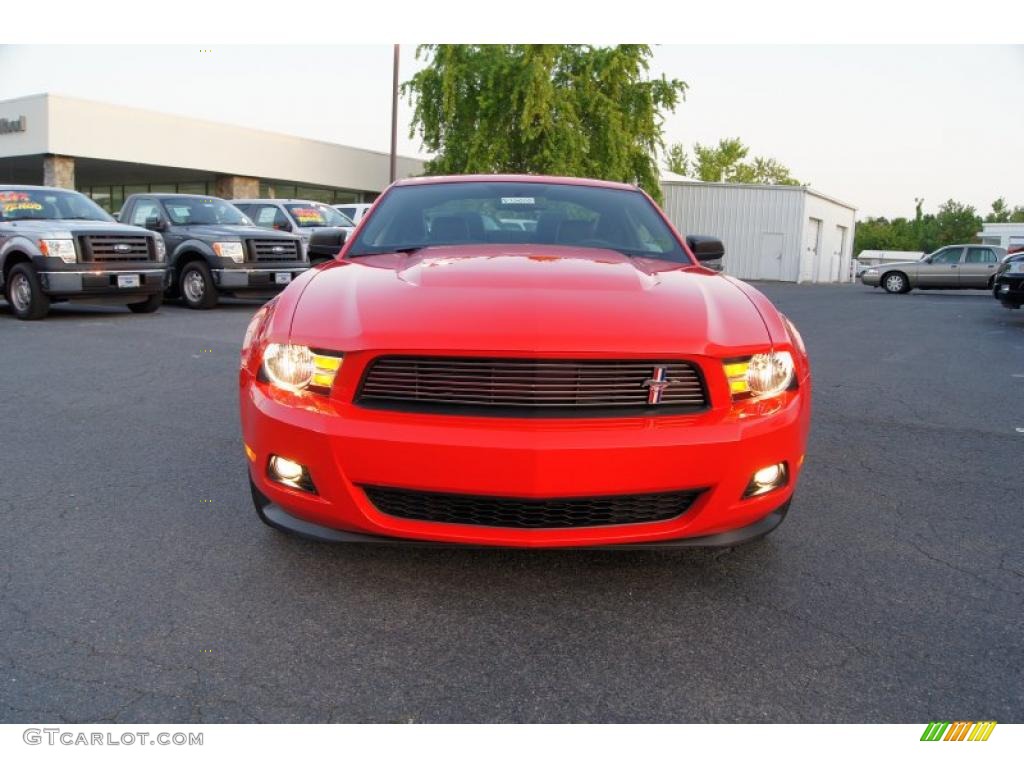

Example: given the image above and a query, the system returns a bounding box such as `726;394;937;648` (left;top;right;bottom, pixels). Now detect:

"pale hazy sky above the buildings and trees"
0;45;1024;217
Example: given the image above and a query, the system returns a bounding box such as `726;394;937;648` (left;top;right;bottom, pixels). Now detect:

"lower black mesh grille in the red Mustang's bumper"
362;485;700;528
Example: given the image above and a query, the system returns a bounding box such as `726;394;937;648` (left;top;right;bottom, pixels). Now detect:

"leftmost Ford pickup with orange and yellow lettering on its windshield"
0;184;167;319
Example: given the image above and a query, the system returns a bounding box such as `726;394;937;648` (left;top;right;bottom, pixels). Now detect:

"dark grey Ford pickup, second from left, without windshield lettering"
121;193;309;309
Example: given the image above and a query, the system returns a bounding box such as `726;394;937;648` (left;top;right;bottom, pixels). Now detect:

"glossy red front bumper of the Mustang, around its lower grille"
241;372;811;548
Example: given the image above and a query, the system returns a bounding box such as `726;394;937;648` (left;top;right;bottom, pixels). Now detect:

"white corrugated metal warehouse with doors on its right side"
662;178;856;283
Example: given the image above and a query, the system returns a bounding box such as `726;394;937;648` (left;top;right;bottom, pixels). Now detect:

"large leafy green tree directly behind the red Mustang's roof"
402;45;687;199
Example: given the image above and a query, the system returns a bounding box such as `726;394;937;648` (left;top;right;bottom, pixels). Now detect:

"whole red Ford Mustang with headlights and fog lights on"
240;176;811;548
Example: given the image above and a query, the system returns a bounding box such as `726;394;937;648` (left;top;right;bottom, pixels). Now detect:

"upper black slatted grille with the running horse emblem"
356;356;708;417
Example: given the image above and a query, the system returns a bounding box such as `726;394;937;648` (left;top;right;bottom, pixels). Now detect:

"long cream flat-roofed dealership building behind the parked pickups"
0;93;423;212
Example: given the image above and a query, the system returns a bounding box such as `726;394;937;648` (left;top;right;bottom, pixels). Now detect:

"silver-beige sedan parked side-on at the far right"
860;245;1007;293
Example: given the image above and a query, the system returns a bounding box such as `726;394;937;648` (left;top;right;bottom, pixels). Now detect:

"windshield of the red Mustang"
348;181;690;263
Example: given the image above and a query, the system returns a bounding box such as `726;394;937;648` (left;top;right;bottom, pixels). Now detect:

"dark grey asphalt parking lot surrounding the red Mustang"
0;285;1024;723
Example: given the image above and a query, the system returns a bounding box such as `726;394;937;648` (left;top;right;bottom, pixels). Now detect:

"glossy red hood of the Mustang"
291;246;770;355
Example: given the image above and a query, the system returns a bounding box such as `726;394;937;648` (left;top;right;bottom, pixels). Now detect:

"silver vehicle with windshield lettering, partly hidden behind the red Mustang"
231;198;355;263
